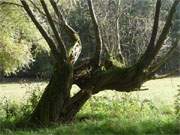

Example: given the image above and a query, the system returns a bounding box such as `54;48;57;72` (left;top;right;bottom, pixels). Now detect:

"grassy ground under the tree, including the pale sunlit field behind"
0;78;180;135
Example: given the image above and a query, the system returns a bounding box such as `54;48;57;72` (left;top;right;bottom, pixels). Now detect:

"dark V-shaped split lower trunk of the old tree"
29;63;91;125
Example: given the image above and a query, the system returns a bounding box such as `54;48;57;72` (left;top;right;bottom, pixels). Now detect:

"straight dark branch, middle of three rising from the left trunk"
41;0;67;60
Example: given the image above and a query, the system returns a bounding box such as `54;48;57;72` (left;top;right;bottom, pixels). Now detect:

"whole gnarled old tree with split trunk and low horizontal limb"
4;0;180;124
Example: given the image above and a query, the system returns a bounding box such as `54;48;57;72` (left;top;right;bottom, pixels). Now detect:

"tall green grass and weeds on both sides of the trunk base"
0;84;180;135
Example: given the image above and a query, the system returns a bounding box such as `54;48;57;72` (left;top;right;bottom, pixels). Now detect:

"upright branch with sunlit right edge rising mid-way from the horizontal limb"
87;0;102;66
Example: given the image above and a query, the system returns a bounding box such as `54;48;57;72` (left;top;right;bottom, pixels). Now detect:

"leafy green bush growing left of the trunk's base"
0;84;42;122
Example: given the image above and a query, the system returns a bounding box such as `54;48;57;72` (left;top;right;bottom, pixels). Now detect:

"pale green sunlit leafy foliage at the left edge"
0;0;48;75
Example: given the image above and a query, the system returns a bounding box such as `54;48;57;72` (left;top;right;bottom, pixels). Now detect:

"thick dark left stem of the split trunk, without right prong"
30;64;73;125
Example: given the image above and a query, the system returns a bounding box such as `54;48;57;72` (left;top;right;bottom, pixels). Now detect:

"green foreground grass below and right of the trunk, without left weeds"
0;97;180;135
